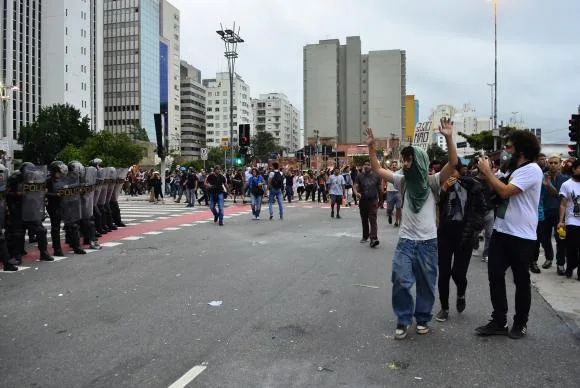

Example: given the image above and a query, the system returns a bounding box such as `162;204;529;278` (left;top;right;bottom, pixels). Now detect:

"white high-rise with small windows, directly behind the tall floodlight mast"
203;72;253;147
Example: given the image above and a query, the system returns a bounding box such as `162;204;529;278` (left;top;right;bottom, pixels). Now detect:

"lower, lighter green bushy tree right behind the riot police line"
58;131;145;167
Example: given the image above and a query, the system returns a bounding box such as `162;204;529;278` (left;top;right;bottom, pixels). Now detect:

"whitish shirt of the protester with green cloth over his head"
393;173;441;241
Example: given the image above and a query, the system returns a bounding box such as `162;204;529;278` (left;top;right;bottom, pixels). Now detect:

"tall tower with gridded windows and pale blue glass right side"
103;0;161;141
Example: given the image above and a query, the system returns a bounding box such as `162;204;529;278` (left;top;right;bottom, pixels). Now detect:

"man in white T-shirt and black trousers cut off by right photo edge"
558;160;580;280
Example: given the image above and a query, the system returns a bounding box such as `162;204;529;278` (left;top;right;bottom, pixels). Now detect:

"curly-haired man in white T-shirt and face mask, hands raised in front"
475;131;544;339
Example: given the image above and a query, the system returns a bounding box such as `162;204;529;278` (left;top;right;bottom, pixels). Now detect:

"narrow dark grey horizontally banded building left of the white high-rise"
180;61;206;159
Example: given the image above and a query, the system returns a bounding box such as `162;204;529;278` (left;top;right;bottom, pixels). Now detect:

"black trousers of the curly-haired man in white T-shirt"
487;230;536;326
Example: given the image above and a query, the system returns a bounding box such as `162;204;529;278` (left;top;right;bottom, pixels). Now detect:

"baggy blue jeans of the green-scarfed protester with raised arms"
391;238;437;325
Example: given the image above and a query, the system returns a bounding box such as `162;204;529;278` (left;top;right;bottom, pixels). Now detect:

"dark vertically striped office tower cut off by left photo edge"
0;0;41;157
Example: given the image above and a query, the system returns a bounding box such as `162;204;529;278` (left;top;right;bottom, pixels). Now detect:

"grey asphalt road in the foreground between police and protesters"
0;204;580;388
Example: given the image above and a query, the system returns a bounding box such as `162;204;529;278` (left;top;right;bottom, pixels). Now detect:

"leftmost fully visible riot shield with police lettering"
18;166;47;222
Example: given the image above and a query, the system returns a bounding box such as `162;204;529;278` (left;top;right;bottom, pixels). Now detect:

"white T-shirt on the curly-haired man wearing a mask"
493;163;544;240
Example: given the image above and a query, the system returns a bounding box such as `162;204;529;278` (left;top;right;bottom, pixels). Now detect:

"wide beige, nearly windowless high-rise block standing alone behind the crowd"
304;36;406;143
